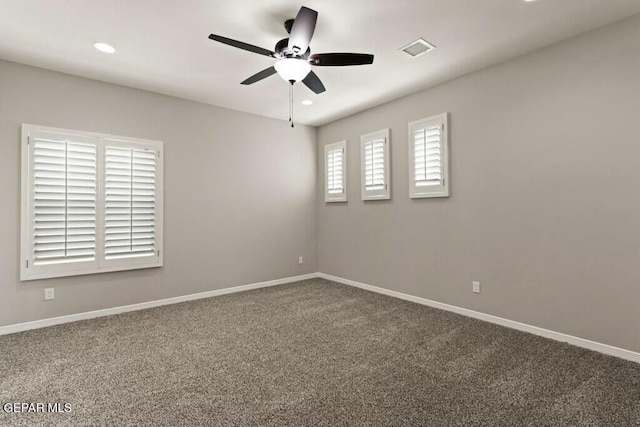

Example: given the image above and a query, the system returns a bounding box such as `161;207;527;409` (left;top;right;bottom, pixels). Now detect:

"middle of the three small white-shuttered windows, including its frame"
360;129;391;200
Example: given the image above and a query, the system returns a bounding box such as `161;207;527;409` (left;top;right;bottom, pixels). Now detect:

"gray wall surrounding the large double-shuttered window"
0;61;317;326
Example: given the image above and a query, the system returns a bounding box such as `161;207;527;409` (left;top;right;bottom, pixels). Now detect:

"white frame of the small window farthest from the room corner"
407;113;451;199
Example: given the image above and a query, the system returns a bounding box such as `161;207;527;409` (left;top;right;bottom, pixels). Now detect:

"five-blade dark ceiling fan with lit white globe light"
209;6;373;94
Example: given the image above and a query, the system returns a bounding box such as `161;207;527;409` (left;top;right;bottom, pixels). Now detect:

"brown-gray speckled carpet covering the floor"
0;279;640;426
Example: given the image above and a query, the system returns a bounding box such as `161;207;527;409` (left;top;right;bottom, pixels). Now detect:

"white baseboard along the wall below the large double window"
0;273;318;335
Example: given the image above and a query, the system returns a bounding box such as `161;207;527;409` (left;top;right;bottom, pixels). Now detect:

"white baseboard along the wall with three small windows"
317;273;640;363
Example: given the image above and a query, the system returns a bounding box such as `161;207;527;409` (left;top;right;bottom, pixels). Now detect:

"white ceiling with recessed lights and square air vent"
0;0;640;125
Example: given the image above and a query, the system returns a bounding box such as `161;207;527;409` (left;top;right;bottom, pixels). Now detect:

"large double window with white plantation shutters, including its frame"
20;125;163;280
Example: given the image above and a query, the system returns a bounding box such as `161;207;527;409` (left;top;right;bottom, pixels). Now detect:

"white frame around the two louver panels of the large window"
20;123;164;281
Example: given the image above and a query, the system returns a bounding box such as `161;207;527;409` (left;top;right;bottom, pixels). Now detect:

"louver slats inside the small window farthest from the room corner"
413;125;442;187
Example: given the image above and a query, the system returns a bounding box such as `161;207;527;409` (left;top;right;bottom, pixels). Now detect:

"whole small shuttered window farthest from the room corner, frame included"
409;114;449;199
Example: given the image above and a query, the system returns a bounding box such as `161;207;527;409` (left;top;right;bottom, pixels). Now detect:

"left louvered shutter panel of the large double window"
31;137;97;266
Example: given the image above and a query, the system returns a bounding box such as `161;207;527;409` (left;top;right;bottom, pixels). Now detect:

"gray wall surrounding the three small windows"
317;16;640;351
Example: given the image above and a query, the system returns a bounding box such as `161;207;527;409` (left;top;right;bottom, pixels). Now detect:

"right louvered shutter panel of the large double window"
105;146;156;259
